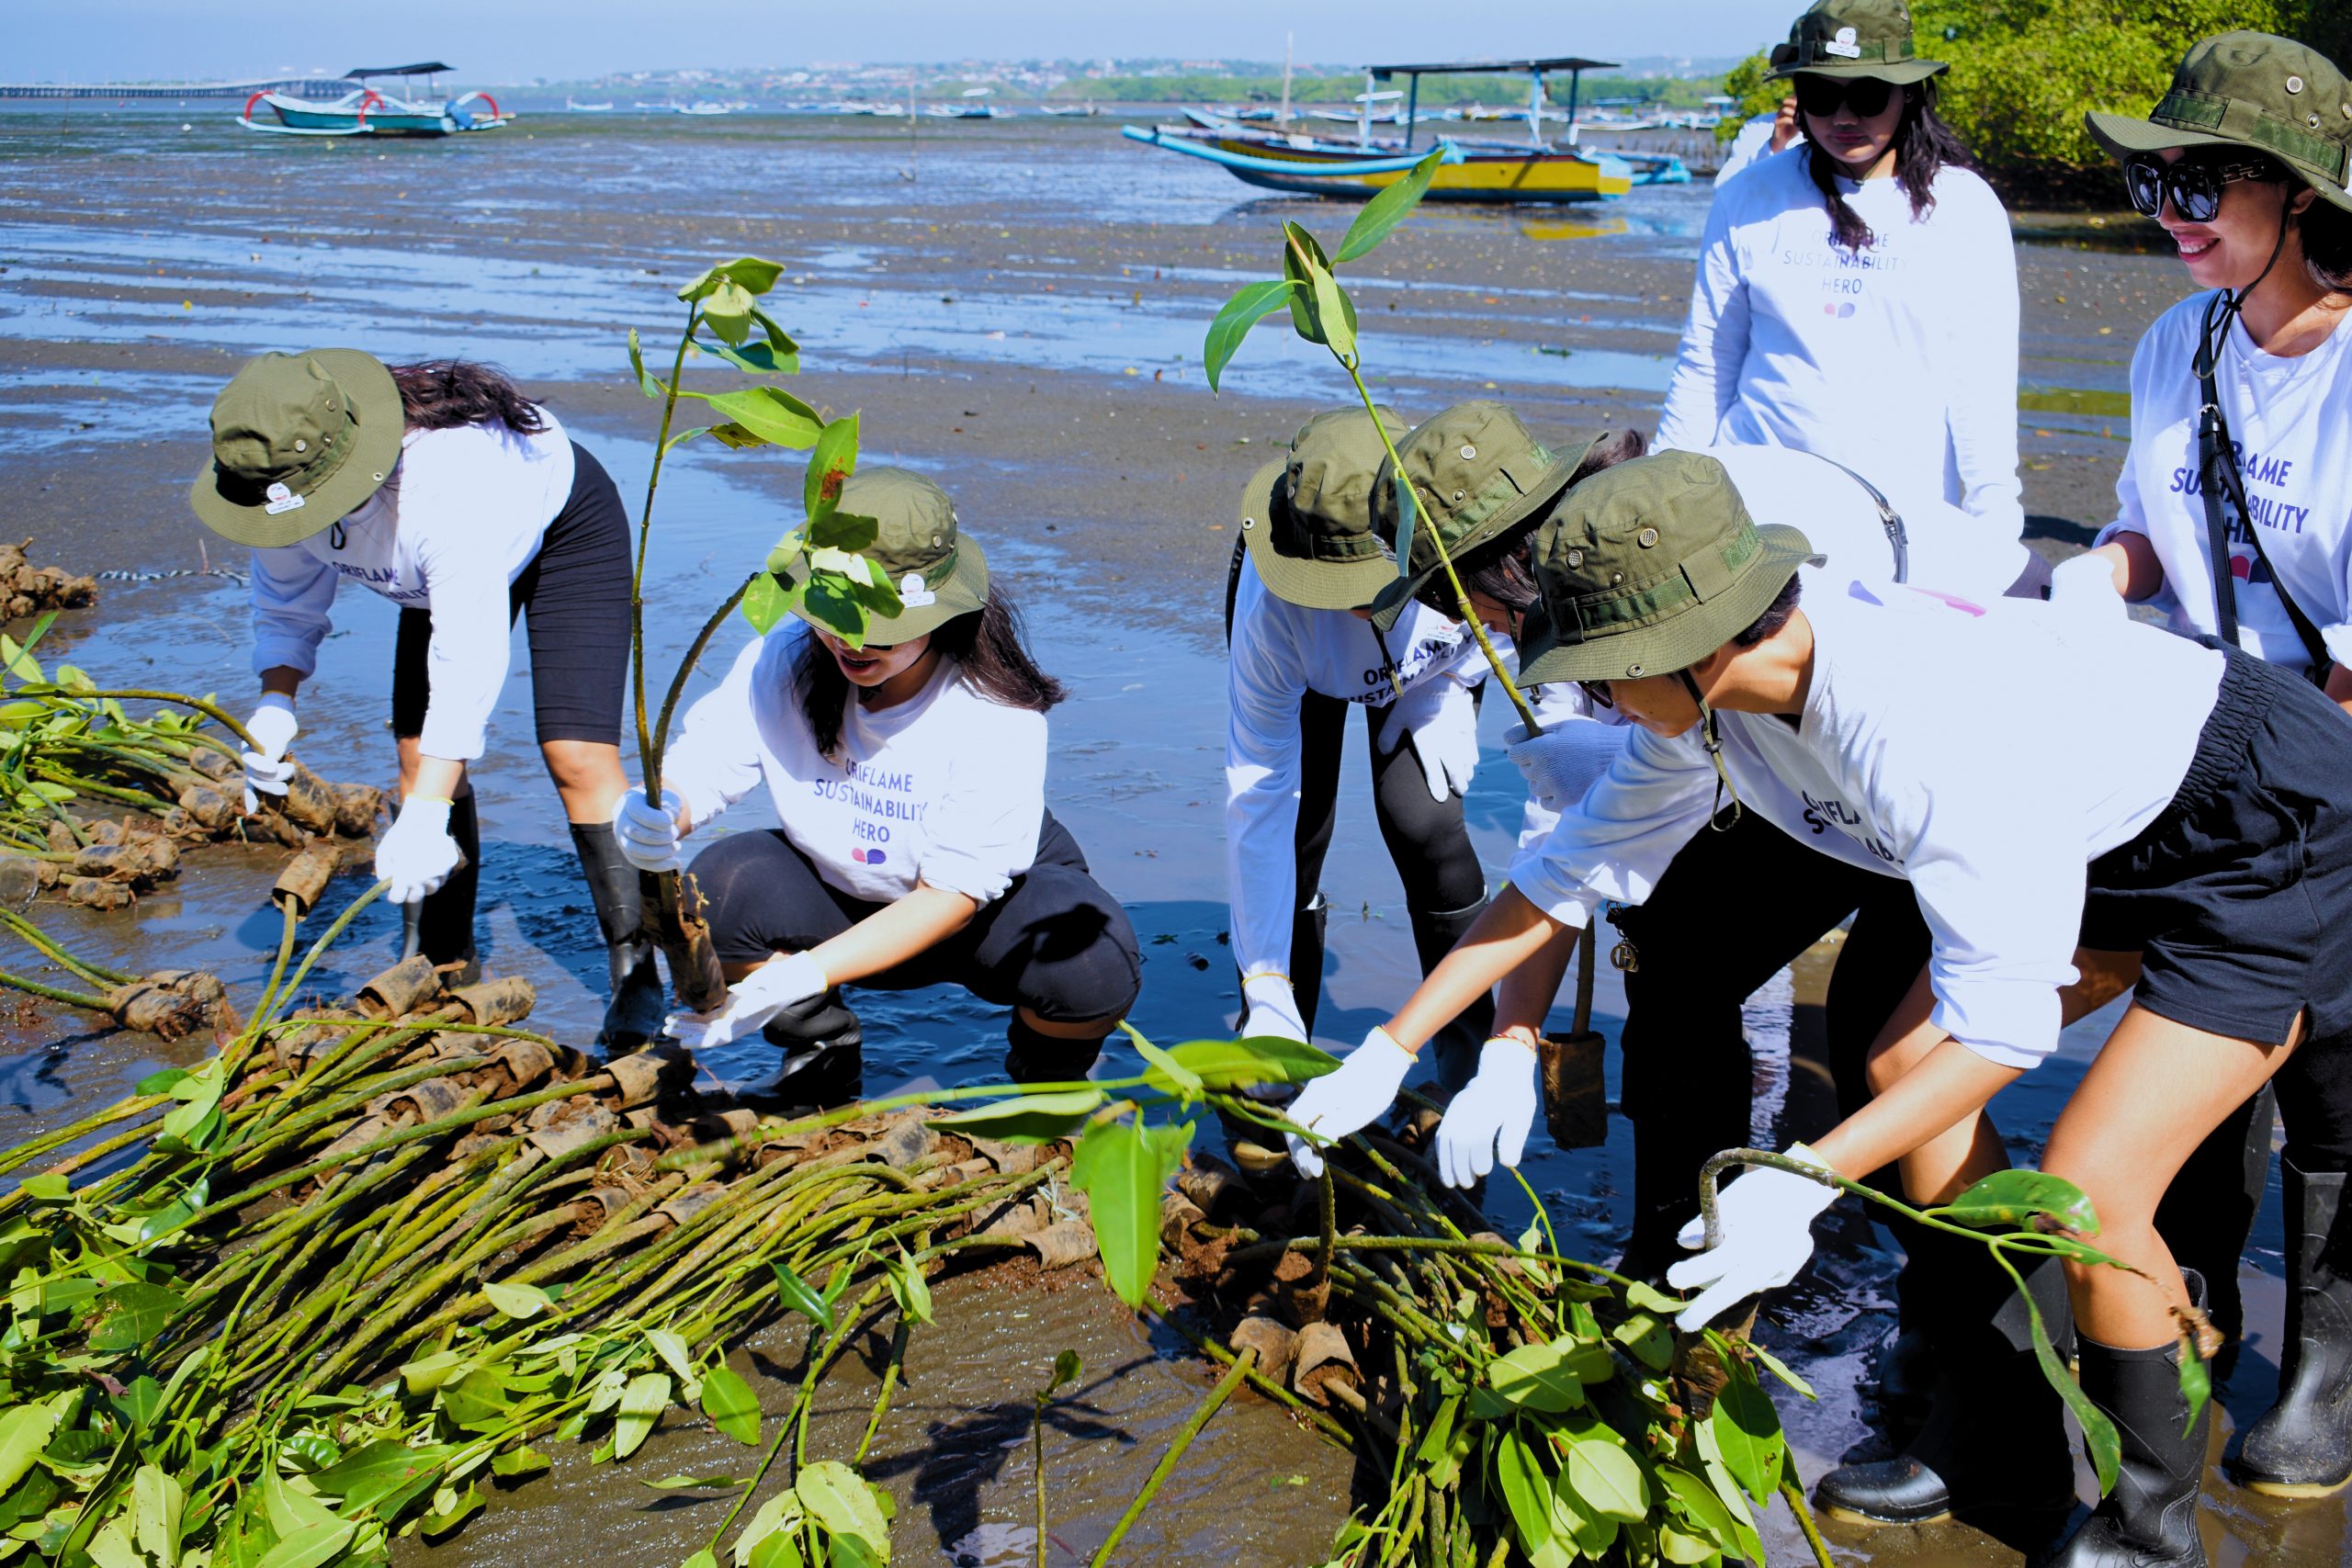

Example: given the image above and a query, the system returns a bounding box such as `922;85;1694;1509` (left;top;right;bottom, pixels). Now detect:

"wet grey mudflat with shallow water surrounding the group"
0;110;2345;1563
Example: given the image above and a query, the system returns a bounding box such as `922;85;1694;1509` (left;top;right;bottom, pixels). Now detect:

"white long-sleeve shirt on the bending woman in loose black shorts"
1510;582;2222;1067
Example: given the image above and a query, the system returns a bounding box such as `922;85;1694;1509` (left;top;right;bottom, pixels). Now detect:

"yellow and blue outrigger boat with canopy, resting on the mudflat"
1122;56;1691;205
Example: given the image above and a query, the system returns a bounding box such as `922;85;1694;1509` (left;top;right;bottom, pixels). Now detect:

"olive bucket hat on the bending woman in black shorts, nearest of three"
1520;451;1820;684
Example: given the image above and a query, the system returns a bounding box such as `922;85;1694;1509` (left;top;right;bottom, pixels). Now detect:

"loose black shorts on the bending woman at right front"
2082;642;2352;1046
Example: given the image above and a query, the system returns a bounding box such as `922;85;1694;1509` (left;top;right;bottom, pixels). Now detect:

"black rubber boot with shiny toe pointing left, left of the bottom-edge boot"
1814;1244;2075;1523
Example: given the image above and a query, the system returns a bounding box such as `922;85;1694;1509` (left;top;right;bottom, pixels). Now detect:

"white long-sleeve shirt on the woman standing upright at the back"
1656;146;2025;538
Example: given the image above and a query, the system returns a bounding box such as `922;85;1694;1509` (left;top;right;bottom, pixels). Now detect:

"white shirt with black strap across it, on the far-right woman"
2098;294;2352;670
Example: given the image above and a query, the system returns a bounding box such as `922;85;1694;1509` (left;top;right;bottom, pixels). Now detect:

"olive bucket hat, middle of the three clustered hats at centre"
1371;398;1600;632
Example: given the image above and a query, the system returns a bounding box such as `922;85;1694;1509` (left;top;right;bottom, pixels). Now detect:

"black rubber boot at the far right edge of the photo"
2230;1159;2352;1497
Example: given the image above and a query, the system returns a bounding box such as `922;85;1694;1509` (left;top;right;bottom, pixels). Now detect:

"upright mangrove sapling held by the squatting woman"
628;256;899;1010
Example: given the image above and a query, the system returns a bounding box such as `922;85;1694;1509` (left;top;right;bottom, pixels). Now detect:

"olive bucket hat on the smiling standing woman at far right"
2082;33;2352;211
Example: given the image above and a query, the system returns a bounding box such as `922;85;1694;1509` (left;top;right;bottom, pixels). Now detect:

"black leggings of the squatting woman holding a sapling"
694;811;1143;1022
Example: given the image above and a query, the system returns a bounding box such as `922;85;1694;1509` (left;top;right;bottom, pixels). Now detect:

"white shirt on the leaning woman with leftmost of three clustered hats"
1226;558;1508;980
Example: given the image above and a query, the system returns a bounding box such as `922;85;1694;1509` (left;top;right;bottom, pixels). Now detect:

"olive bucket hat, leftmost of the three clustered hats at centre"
1239;409;1407;609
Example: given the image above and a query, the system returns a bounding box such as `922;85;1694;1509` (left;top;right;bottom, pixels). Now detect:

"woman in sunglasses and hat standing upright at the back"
1658;0;2025;557
